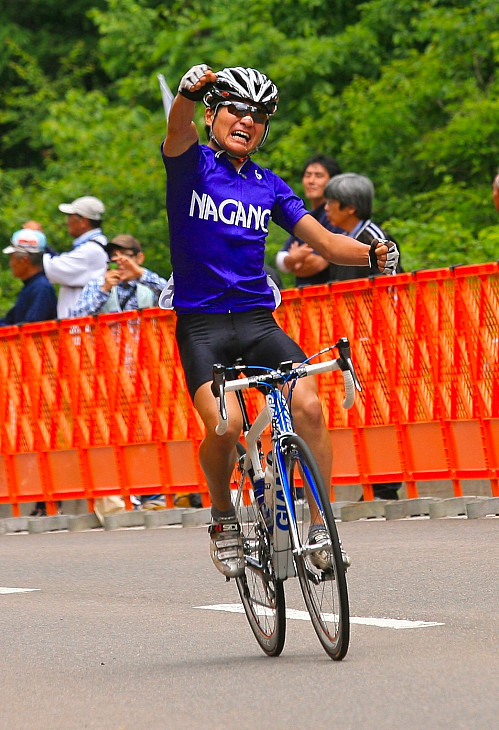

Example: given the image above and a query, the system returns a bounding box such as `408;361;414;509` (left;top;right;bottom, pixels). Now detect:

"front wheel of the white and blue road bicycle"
283;435;350;661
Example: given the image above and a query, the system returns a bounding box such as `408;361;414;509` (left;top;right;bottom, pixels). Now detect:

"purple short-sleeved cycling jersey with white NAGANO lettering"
163;143;308;313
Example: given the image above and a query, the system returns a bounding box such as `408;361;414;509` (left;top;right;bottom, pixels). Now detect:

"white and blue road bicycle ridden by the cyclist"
212;338;361;661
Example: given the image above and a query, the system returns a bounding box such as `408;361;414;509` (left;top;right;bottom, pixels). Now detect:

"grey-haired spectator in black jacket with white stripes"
324;172;402;499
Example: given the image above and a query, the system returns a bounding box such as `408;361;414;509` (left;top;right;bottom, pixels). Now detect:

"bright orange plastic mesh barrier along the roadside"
0;263;499;515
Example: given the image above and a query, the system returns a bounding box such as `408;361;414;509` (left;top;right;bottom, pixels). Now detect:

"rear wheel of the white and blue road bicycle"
235;444;286;656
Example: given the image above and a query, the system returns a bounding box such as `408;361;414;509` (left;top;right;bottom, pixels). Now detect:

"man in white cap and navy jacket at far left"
0;228;57;327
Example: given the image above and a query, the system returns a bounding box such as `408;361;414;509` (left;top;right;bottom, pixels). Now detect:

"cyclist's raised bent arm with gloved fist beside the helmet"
163;66;217;157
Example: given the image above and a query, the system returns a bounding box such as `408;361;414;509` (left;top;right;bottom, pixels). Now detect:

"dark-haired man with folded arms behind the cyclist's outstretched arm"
276;155;343;286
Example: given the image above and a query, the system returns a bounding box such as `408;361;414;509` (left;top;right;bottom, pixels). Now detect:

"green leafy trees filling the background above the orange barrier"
0;0;499;310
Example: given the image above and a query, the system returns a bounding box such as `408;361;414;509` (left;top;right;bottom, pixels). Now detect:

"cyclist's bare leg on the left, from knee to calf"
194;383;242;512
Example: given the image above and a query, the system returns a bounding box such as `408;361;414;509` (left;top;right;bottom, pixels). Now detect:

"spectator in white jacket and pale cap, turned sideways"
43;195;108;319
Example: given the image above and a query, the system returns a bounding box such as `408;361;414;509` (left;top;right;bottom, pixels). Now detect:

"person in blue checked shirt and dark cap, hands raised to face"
69;233;171;509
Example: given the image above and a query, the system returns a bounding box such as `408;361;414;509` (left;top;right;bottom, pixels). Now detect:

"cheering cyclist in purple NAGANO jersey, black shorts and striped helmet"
160;64;398;578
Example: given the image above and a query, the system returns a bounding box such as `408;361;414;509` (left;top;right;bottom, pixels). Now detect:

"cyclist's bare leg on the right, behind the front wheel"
291;370;333;524
